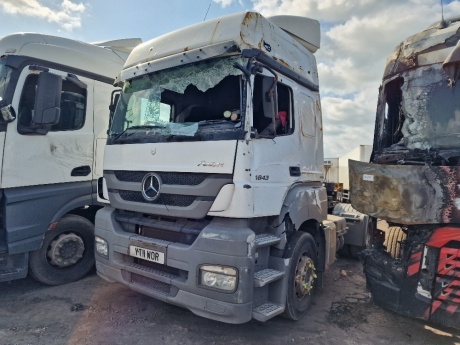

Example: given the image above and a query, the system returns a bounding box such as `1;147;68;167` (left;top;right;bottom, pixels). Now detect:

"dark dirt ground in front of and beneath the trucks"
0;259;460;345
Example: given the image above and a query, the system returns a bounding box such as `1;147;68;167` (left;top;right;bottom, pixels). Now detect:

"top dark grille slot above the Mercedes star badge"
115;170;209;186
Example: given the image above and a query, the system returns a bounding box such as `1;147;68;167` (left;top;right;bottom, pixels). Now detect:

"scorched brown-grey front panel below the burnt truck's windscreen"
349;160;460;225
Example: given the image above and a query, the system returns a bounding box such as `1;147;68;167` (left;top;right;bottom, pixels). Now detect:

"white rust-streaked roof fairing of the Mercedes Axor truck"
122;12;319;85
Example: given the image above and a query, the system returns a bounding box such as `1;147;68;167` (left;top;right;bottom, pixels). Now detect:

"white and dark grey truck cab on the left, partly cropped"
0;33;140;284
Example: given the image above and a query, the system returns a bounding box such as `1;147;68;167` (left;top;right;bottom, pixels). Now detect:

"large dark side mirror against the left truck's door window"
32;72;62;125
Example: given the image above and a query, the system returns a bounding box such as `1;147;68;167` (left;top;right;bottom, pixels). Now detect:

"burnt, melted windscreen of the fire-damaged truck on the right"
377;64;460;155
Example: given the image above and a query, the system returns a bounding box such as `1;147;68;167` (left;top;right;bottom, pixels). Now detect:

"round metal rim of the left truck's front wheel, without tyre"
47;233;85;267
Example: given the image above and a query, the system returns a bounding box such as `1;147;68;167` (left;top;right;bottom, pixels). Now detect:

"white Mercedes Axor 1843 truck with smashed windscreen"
96;12;352;323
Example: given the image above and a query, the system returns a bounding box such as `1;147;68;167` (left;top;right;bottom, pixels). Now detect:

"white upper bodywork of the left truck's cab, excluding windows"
0;33;140;188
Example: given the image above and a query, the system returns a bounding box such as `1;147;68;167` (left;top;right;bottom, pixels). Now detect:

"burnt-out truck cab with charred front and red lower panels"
349;18;460;328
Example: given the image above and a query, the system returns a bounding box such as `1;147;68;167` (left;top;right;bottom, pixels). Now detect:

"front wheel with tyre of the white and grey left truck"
29;215;94;285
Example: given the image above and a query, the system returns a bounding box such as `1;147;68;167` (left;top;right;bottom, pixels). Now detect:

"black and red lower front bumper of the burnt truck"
363;226;460;329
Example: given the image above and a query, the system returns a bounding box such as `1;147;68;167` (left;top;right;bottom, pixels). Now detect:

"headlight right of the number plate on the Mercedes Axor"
200;265;238;292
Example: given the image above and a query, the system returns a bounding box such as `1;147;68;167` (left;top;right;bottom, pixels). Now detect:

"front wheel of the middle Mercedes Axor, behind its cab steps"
283;232;317;320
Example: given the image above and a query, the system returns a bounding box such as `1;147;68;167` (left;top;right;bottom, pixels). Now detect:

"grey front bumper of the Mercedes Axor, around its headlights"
95;207;255;323
